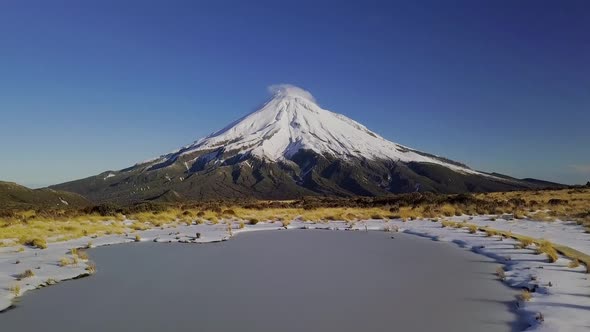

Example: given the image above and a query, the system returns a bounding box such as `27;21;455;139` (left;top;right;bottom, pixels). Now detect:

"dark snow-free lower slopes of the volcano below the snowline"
52;151;563;203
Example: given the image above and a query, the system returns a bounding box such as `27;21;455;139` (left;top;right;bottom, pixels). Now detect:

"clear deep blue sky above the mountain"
0;0;590;186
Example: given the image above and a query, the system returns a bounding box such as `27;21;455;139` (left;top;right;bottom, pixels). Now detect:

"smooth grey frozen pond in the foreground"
0;230;520;332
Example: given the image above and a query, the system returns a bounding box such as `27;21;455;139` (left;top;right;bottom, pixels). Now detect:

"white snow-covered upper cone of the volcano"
150;84;483;174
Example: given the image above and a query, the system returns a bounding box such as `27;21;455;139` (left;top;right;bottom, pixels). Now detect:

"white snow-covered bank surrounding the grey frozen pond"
0;216;590;331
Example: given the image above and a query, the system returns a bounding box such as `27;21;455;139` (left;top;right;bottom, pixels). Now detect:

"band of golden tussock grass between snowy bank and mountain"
0;187;590;246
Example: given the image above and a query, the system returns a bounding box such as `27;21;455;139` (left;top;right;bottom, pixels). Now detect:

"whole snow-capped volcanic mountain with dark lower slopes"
51;85;555;203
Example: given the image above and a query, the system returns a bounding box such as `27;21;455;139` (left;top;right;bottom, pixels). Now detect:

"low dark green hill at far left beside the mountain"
0;181;90;209
